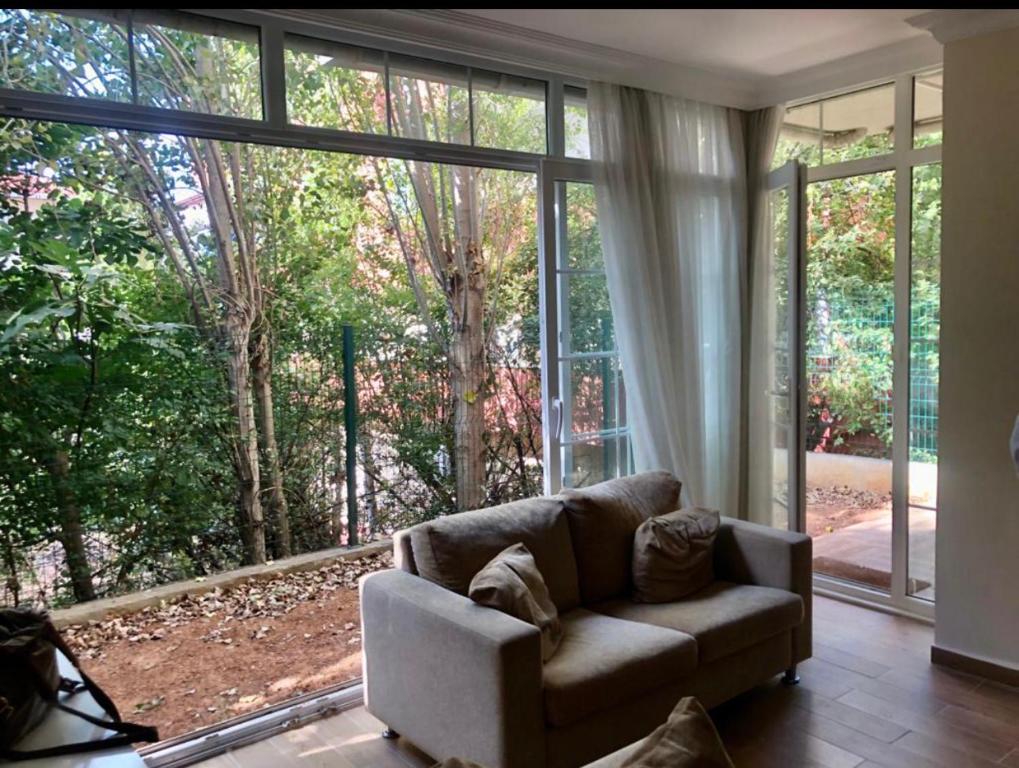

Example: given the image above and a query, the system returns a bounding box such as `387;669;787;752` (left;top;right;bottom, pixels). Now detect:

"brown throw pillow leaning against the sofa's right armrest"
633;507;720;603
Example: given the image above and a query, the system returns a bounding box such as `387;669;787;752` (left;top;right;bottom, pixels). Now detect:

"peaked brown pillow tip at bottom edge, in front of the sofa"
621;696;736;768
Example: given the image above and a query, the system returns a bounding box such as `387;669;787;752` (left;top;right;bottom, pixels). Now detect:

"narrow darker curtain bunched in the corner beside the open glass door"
744;105;795;528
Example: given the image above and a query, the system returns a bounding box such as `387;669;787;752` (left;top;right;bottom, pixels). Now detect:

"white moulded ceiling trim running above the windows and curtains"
257;8;945;109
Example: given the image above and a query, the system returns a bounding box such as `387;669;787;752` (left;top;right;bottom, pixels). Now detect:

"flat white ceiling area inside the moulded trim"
458;8;926;77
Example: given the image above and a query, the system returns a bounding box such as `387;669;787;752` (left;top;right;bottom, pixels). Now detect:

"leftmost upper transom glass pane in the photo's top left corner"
0;8;130;102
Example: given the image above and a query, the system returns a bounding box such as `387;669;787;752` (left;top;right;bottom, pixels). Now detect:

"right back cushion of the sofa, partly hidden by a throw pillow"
561;472;680;605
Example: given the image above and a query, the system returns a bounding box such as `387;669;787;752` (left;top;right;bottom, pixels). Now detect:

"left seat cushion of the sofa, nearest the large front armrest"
543;608;697;727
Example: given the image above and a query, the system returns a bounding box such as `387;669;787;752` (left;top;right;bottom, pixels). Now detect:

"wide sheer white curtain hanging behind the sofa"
588;84;746;516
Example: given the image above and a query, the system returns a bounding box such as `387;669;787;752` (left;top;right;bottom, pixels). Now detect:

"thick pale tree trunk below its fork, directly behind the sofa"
449;235;486;511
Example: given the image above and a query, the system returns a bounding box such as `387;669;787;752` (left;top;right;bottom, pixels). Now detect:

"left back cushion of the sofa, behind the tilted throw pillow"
408;498;580;611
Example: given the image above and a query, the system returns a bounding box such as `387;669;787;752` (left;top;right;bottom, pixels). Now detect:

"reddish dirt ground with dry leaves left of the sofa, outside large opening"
63;554;391;738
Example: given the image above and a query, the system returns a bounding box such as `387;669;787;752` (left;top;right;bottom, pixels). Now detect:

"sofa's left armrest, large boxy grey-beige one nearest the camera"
361;570;545;768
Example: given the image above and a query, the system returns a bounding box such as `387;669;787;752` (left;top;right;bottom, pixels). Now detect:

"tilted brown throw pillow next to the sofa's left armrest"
468;544;562;661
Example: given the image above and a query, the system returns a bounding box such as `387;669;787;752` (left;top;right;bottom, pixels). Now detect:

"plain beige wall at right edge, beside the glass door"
935;23;1019;669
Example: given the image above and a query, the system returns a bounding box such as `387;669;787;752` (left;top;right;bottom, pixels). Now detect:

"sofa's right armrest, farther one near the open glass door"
714;517;813;663
